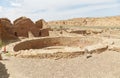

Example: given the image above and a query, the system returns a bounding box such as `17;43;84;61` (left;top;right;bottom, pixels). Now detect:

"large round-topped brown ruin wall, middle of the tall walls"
13;17;39;37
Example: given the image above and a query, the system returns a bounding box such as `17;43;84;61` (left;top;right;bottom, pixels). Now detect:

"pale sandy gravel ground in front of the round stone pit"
0;51;120;78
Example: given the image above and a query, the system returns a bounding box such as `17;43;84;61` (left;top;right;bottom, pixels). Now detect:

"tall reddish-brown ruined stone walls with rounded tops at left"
0;17;49;40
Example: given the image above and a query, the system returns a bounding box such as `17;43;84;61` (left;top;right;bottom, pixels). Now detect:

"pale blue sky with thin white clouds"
0;0;120;21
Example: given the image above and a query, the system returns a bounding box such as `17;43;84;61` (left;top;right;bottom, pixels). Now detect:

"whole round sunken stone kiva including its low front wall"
7;37;108;59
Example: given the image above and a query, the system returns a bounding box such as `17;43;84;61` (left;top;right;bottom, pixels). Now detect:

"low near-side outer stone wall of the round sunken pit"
13;45;108;60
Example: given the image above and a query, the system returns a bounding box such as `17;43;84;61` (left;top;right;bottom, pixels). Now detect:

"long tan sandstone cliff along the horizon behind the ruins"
48;16;120;26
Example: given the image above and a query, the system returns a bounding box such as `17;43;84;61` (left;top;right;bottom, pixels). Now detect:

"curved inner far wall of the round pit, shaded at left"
14;37;101;52
